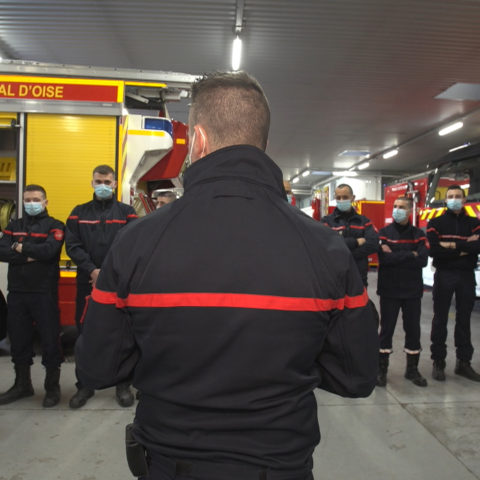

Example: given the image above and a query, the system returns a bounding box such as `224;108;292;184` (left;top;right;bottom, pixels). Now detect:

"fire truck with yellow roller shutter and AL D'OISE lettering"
0;61;196;325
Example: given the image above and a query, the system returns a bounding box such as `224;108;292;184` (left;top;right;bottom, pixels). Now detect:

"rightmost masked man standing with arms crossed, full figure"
427;185;480;382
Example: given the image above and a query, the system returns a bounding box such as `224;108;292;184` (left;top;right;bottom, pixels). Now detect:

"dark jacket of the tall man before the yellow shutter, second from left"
65;195;137;283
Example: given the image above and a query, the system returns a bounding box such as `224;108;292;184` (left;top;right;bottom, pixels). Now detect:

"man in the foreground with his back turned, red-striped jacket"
77;72;378;480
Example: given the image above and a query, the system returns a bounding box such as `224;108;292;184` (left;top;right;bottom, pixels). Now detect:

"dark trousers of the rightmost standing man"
430;269;475;362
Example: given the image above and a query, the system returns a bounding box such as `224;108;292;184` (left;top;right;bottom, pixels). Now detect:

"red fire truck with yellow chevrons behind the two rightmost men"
385;143;480;297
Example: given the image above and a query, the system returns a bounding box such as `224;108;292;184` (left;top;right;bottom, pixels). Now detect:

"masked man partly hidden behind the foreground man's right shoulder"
321;183;378;286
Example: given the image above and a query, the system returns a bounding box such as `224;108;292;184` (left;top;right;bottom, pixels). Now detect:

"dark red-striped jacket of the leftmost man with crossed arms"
0;210;65;294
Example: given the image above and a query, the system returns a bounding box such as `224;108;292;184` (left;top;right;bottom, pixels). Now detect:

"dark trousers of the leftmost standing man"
7;292;63;368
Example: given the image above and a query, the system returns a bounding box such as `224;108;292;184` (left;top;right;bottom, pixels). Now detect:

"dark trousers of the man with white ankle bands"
380;296;422;353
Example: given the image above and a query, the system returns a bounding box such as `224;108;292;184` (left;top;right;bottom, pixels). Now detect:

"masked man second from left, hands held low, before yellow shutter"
65;165;137;408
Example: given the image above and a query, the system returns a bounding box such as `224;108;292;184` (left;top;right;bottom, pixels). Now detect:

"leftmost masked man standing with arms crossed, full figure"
0;185;65;407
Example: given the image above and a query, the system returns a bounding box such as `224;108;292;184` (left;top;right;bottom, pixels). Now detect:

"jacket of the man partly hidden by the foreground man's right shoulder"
321;208;378;285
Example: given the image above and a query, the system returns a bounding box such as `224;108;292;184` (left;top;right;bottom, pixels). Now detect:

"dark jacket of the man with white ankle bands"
377;222;428;298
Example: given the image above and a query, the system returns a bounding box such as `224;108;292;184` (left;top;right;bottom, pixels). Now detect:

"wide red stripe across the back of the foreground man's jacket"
92;288;368;312
